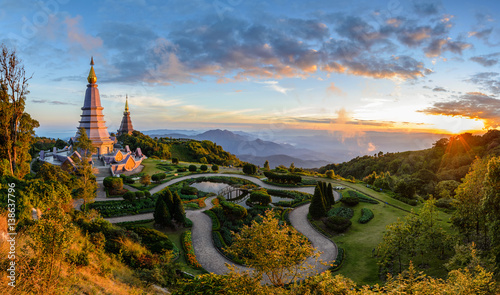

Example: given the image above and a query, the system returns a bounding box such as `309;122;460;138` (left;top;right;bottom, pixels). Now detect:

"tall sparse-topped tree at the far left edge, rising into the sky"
0;44;40;178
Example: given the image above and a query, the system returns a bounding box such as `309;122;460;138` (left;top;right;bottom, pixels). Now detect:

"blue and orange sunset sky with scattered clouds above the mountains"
0;0;500;149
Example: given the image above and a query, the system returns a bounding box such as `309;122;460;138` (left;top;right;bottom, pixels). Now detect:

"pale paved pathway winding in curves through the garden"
102;173;340;275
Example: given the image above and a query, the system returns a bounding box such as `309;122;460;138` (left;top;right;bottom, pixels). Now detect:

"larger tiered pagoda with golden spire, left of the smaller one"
73;58;115;155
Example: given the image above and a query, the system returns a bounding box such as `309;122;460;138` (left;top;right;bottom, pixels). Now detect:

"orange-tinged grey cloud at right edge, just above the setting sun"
418;92;500;128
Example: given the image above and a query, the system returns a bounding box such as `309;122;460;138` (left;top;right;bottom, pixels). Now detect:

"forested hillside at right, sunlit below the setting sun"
319;130;500;198
